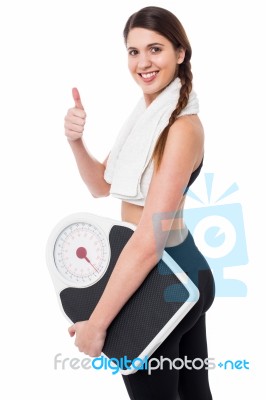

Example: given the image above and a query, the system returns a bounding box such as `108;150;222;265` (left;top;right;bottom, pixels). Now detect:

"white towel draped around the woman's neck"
104;78;199;200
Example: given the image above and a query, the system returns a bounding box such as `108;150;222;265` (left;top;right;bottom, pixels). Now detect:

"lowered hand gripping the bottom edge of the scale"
68;320;106;357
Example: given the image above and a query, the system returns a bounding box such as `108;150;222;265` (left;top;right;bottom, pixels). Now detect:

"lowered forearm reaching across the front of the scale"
90;233;158;329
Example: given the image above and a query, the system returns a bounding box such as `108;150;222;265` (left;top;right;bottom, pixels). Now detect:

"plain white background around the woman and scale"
0;0;266;400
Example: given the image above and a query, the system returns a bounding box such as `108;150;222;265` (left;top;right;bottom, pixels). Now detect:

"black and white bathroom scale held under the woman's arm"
46;213;199;375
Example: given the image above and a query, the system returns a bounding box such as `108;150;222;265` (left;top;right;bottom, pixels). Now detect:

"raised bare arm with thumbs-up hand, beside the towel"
65;88;110;197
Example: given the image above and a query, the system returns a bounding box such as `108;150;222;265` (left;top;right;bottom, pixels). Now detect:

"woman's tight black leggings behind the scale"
122;233;214;400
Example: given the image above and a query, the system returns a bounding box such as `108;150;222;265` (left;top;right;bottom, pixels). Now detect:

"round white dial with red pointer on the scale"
54;222;110;287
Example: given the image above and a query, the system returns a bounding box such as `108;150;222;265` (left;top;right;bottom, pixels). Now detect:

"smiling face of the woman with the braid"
127;28;185;106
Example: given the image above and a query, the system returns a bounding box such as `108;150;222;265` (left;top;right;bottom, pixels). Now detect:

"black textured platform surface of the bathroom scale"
60;225;190;368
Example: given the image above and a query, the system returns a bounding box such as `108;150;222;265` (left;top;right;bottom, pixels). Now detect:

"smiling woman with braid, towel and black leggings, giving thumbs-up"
65;7;214;400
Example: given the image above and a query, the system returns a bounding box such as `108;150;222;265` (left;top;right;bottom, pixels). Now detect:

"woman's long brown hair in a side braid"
123;7;193;169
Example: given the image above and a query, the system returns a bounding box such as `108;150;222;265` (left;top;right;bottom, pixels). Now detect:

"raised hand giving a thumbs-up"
65;88;86;140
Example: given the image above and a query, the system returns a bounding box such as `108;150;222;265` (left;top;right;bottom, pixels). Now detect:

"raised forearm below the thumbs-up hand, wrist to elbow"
69;139;110;197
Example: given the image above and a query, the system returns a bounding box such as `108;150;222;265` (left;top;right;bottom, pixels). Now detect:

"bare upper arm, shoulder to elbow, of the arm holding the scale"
141;115;204;215
